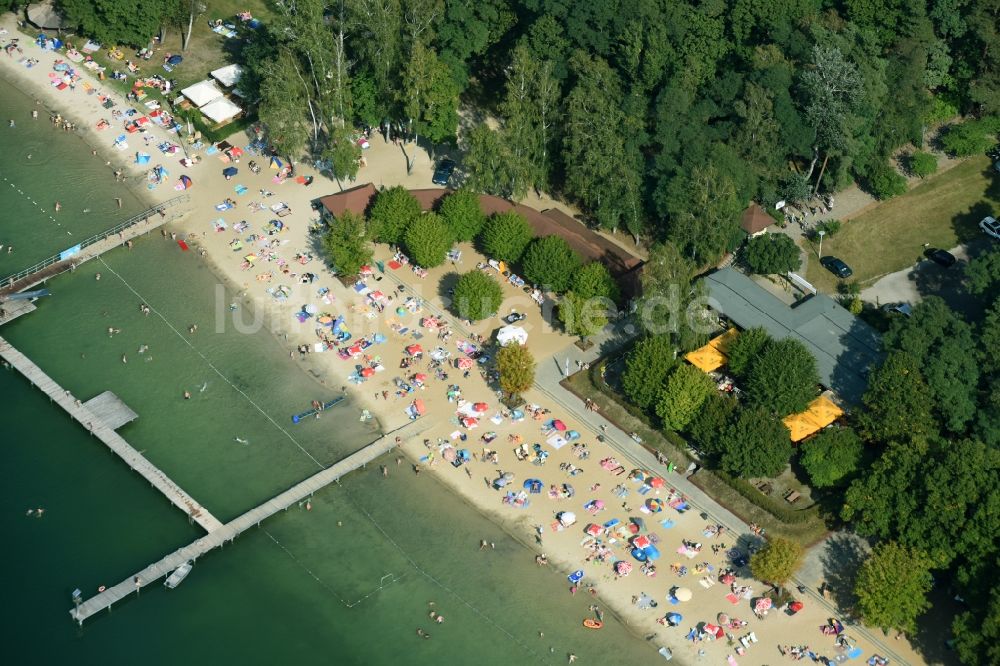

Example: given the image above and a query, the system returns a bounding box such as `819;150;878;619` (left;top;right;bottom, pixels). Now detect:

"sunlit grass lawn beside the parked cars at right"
807;155;1000;293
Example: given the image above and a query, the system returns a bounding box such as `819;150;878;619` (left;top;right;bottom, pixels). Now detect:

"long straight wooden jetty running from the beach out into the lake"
69;420;425;625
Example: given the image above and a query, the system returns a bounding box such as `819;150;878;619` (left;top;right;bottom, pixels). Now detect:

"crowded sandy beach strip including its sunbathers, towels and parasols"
0;16;920;664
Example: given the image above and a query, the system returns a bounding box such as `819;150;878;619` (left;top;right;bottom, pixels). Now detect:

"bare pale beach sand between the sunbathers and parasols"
0;16;932;664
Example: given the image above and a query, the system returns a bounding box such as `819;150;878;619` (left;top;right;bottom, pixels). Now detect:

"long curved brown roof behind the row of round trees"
319;183;640;278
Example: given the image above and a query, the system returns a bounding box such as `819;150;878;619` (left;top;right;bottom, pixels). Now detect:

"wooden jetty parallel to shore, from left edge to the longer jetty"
0;337;222;532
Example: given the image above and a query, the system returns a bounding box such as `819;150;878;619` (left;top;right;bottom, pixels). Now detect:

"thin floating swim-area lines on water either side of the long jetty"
98;256;547;662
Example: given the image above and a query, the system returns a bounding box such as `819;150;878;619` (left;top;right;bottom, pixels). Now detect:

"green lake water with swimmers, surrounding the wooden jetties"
0;79;662;665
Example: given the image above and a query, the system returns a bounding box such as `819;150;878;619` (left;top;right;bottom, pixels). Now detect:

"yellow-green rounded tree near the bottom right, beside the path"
854;541;932;633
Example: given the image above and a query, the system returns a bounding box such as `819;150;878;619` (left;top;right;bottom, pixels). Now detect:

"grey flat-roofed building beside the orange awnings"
704;268;882;405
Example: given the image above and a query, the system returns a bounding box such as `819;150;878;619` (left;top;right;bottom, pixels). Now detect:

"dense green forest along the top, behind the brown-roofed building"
227;0;1000;265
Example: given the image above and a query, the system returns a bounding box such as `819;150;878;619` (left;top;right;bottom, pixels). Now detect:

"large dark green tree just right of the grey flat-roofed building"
857;351;936;442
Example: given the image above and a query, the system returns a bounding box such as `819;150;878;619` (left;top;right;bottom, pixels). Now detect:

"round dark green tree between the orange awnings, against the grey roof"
746;338;819;416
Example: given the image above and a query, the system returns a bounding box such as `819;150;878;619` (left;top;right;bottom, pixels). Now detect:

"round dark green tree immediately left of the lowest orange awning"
719;407;792;479
